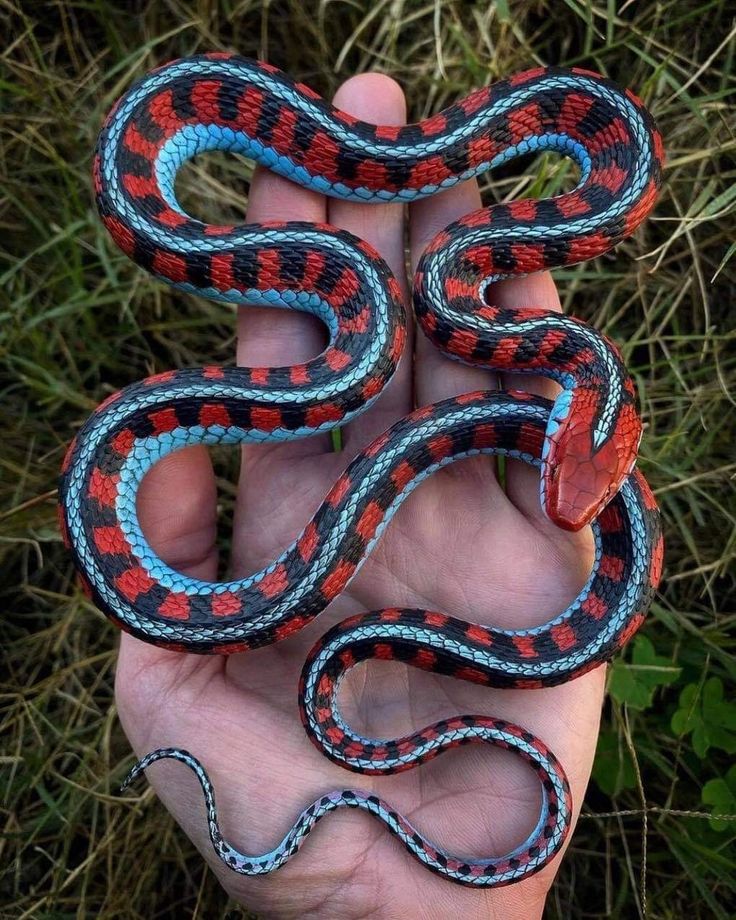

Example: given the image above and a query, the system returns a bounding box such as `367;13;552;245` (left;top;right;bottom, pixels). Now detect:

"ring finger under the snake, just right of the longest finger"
409;179;496;406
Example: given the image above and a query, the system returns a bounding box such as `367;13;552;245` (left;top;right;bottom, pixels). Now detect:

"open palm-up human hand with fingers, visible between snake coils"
116;74;605;920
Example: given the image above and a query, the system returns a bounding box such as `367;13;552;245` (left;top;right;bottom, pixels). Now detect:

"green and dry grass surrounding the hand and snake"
0;0;736;920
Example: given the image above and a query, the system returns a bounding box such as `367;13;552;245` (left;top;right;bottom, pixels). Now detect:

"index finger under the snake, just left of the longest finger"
237;166;331;458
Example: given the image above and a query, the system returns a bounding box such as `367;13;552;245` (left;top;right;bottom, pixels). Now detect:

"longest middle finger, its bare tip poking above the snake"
327;73;412;448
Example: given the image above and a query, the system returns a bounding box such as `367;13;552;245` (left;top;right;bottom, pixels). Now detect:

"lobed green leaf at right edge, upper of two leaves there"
671;677;736;759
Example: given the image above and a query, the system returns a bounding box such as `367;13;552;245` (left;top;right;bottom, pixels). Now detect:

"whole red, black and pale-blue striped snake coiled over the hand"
59;53;664;888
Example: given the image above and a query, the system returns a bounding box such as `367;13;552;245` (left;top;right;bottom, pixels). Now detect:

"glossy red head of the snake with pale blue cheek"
542;387;642;530
